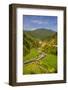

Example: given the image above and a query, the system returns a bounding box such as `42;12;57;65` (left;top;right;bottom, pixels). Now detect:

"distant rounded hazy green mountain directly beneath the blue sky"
24;28;55;40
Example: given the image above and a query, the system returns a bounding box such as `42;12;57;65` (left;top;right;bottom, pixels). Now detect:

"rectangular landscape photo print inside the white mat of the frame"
23;15;57;75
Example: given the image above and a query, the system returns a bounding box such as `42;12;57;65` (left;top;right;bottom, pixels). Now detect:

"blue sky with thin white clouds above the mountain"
23;15;57;32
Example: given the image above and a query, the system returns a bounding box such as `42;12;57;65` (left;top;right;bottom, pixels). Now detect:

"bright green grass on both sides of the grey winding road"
23;48;57;74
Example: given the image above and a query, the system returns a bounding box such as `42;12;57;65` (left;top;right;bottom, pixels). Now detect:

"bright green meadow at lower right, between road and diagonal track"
40;54;57;72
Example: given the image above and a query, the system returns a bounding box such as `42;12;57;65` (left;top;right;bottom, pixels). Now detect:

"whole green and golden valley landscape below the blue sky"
23;30;57;75
